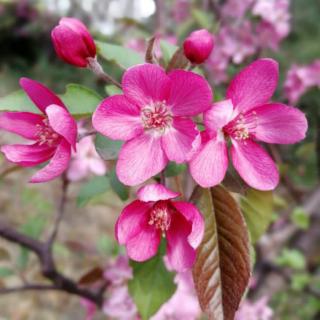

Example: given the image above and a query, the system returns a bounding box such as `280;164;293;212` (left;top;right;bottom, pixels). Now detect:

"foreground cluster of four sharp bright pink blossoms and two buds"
0;16;307;278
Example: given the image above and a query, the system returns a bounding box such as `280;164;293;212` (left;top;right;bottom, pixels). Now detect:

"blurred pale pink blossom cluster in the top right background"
207;0;291;84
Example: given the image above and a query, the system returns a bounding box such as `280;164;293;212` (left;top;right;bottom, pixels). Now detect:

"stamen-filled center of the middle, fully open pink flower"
141;101;172;131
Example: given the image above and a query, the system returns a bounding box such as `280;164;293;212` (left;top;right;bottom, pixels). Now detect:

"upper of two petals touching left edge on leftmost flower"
0;112;44;140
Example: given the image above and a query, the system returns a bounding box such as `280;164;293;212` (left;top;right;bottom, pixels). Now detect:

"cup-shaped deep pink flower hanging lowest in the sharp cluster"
116;184;204;271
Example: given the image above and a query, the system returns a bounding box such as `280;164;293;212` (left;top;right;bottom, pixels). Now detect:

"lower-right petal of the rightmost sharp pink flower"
231;140;279;190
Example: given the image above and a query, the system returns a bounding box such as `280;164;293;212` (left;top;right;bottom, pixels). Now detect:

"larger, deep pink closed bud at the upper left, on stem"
51;18;96;68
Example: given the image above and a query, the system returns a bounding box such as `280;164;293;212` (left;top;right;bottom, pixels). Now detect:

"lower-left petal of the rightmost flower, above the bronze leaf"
189;137;228;188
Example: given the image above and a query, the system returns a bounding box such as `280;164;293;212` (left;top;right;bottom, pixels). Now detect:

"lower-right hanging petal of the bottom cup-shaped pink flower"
166;214;196;272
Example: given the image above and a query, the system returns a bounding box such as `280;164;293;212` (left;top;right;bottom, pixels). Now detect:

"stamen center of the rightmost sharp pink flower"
223;111;258;140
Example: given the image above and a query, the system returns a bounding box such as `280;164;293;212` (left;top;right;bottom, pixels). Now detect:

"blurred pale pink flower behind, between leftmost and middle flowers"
67;136;107;181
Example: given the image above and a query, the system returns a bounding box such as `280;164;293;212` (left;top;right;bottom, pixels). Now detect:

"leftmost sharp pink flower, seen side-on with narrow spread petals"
0;78;77;183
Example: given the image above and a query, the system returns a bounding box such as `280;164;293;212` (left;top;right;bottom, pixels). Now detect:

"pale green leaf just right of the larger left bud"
95;41;144;69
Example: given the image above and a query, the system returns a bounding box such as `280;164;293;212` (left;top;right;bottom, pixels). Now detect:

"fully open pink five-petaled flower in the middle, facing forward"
92;64;212;185
